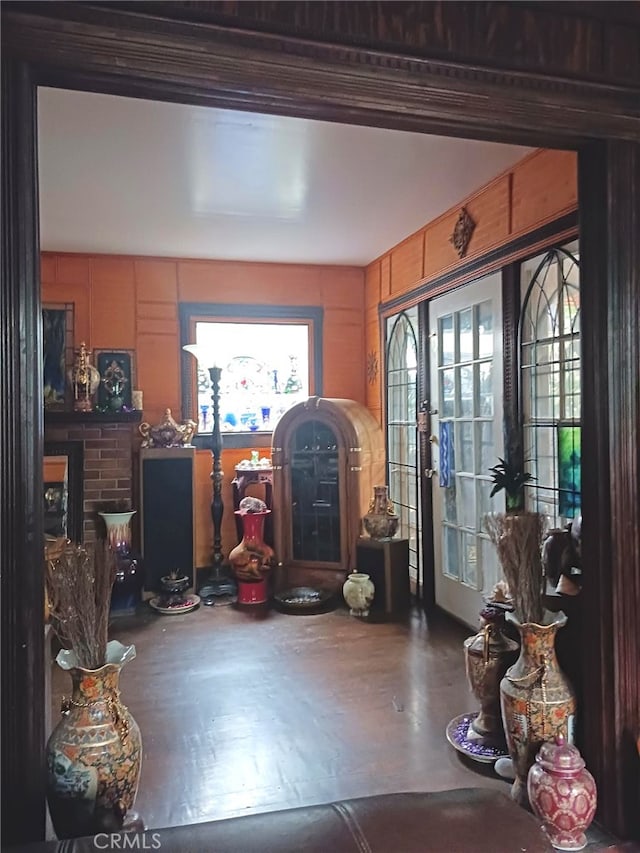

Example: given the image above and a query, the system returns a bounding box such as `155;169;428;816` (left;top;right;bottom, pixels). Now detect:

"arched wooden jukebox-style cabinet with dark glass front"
271;397;385;589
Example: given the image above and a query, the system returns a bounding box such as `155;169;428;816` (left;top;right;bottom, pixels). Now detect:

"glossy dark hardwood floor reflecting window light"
52;606;636;849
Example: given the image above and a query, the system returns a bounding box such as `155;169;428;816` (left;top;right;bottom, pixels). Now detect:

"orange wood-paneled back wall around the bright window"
41;252;365;565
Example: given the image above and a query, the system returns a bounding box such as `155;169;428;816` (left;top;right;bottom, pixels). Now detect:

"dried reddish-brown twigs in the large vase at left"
46;542;116;669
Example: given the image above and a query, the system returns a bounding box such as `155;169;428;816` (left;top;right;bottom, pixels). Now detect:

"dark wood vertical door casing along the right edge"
578;141;640;838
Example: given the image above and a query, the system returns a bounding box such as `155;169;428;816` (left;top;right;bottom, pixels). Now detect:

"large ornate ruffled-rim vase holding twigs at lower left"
47;640;142;838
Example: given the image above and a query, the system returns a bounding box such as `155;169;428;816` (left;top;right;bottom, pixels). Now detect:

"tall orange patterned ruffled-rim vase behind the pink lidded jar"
500;611;576;807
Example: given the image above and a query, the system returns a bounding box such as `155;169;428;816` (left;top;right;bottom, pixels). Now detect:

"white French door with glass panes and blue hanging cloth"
427;272;504;627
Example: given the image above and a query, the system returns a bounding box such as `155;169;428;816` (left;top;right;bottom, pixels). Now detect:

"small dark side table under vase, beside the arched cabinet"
356;536;411;617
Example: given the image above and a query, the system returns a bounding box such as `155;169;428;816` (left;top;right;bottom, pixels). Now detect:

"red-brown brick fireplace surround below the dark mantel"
44;411;141;542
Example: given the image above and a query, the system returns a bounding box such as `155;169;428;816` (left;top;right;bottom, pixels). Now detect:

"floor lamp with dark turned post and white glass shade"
183;344;236;605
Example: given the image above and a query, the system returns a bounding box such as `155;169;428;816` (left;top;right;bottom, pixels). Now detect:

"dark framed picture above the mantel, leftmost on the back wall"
42;303;73;409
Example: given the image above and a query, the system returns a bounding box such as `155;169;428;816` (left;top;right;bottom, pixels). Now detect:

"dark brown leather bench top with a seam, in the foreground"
15;788;553;853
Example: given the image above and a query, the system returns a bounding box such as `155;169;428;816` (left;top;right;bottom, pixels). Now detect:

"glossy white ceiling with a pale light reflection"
38;88;532;266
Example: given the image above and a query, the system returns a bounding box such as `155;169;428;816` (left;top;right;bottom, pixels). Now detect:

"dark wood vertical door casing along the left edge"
0;56;46;848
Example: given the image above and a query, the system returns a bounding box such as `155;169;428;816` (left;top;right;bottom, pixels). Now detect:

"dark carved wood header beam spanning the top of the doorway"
4;2;640;147
